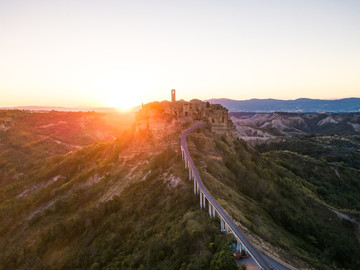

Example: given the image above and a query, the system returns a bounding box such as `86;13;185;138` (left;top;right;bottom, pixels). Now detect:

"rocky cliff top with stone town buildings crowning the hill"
135;99;234;134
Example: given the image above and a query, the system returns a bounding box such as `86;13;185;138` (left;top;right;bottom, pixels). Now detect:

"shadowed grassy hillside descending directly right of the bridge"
189;127;360;269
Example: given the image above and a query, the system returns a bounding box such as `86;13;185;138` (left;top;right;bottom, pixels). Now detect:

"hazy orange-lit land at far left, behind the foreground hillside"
0;110;134;184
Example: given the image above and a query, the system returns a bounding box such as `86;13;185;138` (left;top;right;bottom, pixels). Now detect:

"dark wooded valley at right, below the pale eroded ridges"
257;136;360;211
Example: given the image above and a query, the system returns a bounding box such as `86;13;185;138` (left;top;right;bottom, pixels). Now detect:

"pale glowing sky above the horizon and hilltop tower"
0;0;360;108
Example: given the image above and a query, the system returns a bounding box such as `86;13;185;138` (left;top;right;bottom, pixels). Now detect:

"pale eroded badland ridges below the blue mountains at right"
229;112;360;145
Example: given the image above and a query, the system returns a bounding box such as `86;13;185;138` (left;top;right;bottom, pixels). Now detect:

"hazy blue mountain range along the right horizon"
208;98;360;113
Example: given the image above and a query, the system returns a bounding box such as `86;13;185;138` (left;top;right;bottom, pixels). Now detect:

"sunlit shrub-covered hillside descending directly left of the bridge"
0;119;236;269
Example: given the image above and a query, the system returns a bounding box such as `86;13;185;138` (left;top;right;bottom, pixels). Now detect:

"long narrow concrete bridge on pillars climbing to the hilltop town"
181;123;275;270
